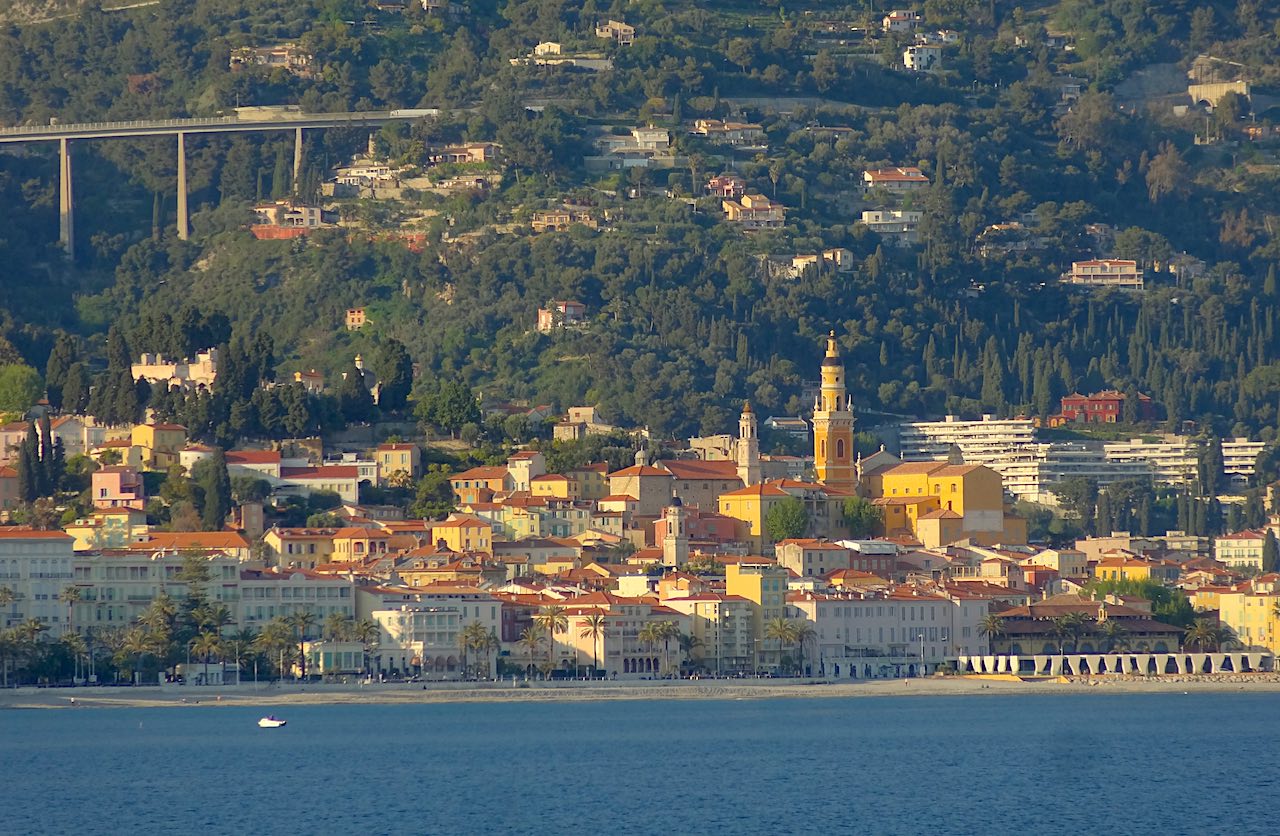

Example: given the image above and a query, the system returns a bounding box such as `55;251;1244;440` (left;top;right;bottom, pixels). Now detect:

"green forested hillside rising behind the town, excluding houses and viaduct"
0;0;1280;440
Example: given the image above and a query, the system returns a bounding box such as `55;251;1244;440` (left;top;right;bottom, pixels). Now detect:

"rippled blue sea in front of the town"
0;694;1280;835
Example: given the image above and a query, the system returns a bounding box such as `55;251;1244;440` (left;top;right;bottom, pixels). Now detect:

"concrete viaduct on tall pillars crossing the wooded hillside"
0;109;439;256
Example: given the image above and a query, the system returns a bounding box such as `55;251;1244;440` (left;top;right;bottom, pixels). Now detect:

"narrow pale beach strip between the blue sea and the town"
0;673;1280;711
